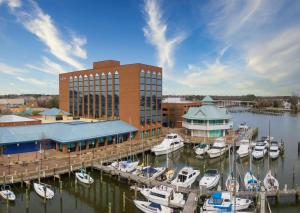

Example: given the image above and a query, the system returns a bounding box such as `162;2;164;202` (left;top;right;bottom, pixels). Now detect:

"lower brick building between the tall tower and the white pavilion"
162;97;201;128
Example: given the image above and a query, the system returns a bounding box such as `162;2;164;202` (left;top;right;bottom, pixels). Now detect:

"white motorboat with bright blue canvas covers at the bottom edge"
203;192;252;212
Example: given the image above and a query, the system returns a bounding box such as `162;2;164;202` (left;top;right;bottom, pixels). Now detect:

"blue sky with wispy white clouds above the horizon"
0;0;300;95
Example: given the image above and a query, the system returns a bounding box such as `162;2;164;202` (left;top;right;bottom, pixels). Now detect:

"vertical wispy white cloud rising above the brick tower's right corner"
143;0;184;74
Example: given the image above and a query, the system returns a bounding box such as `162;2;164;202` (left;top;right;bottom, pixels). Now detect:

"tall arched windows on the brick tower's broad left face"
69;71;119;118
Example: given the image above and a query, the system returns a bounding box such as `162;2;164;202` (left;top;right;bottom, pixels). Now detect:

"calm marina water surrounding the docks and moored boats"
0;113;300;213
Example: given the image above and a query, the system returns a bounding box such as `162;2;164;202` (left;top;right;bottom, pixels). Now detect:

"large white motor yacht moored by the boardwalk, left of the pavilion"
151;133;184;155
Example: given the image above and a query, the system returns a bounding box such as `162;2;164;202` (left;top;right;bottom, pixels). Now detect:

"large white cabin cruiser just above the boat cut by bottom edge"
140;185;185;208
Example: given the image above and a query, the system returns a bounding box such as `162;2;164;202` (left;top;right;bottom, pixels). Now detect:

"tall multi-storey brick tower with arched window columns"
59;60;162;137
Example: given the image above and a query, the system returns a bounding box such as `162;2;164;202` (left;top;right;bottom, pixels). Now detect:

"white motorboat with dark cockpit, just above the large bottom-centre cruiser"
171;167;200;188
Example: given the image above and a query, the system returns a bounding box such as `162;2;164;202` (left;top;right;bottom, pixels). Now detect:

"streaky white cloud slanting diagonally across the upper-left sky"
13;1;87;69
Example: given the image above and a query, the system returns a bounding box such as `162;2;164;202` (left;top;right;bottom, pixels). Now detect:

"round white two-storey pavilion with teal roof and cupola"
182;96;232;138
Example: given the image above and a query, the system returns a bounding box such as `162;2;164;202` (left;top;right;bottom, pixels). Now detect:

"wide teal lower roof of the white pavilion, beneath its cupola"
183;105;231;120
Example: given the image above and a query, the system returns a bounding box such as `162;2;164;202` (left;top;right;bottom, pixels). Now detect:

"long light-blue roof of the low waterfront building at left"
0;120;137;145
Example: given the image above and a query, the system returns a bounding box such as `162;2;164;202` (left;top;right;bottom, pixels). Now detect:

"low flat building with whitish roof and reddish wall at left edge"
0;115;41;126
